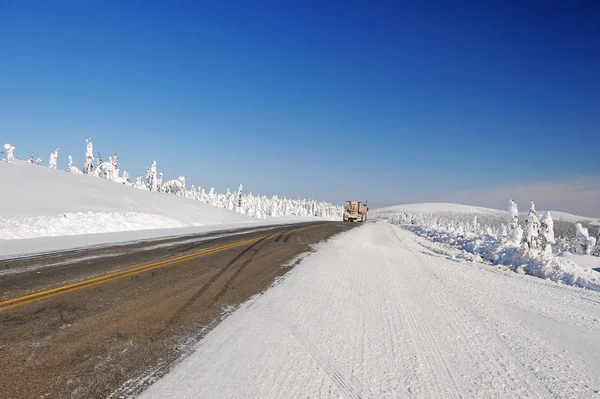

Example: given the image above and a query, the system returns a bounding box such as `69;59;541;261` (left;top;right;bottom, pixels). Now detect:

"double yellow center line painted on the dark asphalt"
0;225;319;312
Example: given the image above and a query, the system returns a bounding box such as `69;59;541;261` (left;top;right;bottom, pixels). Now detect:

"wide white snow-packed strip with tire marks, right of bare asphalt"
142;224;600;398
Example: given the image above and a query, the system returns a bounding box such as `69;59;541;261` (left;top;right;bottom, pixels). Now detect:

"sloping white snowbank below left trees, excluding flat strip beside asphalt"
0;162;256;240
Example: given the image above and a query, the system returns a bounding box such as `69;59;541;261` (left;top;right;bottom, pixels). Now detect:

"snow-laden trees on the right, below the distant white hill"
389;200;600;256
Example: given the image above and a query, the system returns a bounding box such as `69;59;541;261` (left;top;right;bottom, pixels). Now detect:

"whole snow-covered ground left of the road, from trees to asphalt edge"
0;162;332;257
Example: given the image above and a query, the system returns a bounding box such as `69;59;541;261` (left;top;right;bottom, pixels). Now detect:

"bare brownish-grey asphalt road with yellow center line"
0;222;356;399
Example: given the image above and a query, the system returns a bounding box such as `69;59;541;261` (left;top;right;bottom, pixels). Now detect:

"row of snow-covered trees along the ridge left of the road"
4;138;343;219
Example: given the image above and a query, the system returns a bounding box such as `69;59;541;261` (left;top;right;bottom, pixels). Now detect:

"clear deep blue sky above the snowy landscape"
0;0;600;216
